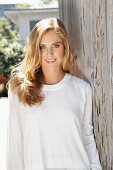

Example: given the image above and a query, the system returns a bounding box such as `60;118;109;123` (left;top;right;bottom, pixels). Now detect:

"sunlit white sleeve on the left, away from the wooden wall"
6;90;24;170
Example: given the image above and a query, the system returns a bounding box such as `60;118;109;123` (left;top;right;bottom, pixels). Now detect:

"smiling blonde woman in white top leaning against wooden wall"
7;18;101;170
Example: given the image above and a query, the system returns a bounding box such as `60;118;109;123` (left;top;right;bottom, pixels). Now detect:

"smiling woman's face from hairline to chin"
40;30;65;72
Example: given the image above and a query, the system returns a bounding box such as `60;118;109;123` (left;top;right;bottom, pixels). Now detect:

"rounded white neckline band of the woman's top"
42;73;70;90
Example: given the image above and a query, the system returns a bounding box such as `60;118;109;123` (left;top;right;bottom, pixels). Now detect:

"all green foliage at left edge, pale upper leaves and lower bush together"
0;18;24;77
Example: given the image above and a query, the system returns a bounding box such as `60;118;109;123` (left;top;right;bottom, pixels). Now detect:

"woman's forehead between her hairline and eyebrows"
40;30;62;43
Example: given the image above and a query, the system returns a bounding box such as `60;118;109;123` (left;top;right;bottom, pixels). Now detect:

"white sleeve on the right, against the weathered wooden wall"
82;84;102;170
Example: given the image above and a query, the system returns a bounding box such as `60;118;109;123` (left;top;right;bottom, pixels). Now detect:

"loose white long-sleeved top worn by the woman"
7;73;101;170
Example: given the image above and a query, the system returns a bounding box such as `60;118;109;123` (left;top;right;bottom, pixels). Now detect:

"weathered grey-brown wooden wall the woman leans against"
59;0;113;170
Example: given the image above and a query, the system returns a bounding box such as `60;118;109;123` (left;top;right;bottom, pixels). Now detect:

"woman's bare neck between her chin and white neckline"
43;70;65;85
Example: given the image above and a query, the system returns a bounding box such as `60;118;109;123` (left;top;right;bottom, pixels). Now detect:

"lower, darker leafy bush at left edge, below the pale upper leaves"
0;38;24;77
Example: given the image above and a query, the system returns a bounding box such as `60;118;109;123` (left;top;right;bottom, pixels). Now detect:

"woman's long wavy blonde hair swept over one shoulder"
9;18;74;106
